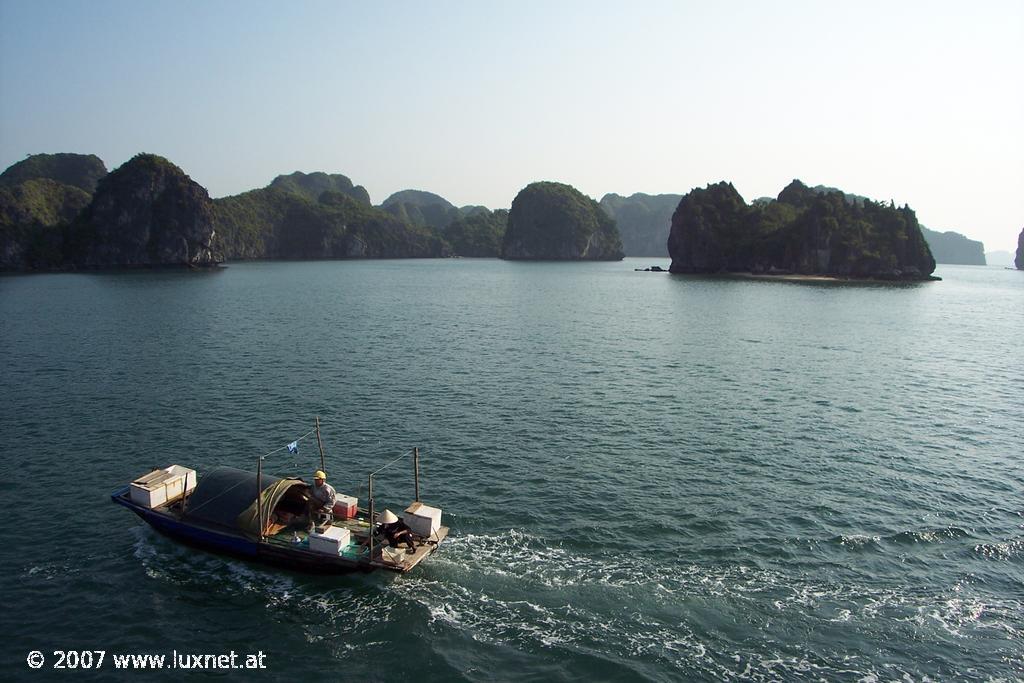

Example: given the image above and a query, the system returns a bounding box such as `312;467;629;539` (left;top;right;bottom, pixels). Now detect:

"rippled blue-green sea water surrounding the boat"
0;259;1024;681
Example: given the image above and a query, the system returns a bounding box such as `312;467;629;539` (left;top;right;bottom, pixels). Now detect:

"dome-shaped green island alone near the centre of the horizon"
501;182;624;261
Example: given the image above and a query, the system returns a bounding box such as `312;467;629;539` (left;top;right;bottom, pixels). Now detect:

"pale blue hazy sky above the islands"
0;0;1024;252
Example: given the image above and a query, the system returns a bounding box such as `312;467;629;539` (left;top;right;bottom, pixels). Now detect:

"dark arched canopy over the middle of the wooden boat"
185;467;306;536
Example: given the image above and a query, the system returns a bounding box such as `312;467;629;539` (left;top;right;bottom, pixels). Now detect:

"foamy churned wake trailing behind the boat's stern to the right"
391;531;1024;679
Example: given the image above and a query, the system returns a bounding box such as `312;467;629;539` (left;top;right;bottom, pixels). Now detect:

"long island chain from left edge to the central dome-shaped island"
0;154;508;270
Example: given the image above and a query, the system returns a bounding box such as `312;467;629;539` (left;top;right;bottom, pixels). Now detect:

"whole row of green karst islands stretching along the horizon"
0;154;1024;280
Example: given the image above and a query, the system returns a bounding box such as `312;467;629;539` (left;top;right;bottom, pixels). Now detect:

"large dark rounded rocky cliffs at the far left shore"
0;154;219;270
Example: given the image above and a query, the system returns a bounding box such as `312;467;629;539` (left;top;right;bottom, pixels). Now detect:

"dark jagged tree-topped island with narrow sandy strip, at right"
669;180;935;280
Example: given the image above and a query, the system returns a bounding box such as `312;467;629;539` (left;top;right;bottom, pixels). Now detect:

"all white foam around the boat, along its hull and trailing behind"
123;527;1022;681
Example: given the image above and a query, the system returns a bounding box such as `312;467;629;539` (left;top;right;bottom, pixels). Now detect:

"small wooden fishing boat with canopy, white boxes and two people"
111;419;449;573
